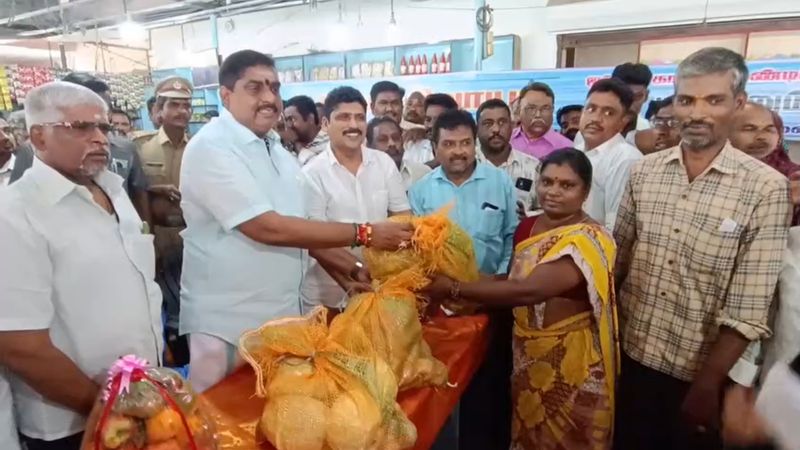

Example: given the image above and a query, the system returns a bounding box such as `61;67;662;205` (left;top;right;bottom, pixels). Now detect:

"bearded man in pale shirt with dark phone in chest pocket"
477;99;539;215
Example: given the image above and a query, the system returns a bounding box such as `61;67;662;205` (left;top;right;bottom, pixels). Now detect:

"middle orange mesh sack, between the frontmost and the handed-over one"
334;269;447;390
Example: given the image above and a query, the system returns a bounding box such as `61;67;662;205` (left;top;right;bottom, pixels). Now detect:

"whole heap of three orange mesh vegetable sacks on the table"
239;211;478;450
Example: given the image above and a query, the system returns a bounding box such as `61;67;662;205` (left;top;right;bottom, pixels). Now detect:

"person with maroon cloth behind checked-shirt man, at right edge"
730;102;800;226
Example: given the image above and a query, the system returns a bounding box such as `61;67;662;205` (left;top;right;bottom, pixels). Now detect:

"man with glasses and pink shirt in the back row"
511;82;572;160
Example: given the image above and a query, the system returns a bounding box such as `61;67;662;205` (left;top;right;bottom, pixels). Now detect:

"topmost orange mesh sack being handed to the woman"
364;207;480;314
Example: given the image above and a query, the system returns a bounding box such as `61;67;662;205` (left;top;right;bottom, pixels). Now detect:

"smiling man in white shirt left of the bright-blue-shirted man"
300;86;411;313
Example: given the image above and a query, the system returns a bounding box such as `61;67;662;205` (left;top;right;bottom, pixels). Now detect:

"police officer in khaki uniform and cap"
137;77;192;365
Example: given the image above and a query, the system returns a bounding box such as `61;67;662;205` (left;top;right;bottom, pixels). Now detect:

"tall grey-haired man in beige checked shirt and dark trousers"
614;48;792;450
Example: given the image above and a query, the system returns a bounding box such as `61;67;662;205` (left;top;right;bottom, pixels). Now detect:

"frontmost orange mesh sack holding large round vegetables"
239;308;416;450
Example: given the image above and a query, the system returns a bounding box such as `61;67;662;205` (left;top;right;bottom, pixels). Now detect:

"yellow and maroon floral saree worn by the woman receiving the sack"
509;224;619;450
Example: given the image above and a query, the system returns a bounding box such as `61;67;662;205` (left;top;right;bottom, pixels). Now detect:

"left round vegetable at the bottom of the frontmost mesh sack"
259;395;328;450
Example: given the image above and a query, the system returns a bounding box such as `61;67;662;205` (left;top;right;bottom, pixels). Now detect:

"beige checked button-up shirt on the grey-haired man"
614;143;792;381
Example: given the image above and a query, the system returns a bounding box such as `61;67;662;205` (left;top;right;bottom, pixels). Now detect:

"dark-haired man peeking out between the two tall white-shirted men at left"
283;95;329;166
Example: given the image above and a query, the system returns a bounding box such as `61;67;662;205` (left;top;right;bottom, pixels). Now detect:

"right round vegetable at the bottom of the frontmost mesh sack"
326;388;381;450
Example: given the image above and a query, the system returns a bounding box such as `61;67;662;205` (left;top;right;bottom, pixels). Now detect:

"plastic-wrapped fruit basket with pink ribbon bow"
82;355;218;450
